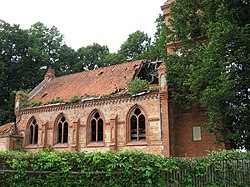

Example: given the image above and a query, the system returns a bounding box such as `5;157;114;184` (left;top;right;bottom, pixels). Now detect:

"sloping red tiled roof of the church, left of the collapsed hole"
30;60;143;104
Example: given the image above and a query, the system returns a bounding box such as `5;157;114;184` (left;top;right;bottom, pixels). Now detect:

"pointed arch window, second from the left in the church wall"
57;115;69;143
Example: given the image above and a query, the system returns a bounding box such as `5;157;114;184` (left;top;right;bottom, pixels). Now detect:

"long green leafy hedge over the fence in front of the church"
0;149;250;186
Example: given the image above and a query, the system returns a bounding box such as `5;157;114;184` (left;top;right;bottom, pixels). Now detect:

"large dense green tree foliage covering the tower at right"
166;0;250;149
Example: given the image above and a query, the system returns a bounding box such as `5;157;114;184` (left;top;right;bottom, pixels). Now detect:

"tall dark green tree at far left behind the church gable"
0;20;77;124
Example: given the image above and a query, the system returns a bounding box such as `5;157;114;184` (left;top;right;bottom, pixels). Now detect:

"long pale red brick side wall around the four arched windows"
17;93;163;154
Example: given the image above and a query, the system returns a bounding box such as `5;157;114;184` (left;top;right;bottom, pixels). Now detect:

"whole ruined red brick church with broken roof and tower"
0;3;225;157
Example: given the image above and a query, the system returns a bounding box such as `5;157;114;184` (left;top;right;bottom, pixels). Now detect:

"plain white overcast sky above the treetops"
0;0;166;52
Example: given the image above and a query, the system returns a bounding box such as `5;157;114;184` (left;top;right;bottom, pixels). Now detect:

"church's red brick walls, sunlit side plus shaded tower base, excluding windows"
14;93;225;157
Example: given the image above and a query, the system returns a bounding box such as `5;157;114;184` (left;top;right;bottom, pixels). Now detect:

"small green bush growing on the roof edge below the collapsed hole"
127;77;149;95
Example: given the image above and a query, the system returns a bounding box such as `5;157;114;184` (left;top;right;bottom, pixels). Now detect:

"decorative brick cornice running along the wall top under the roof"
19;92;159;115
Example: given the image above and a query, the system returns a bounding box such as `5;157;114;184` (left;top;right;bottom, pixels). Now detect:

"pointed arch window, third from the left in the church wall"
90;112;103;142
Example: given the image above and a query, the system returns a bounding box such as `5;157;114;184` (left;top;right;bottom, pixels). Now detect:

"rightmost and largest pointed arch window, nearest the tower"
130;108;146;142
